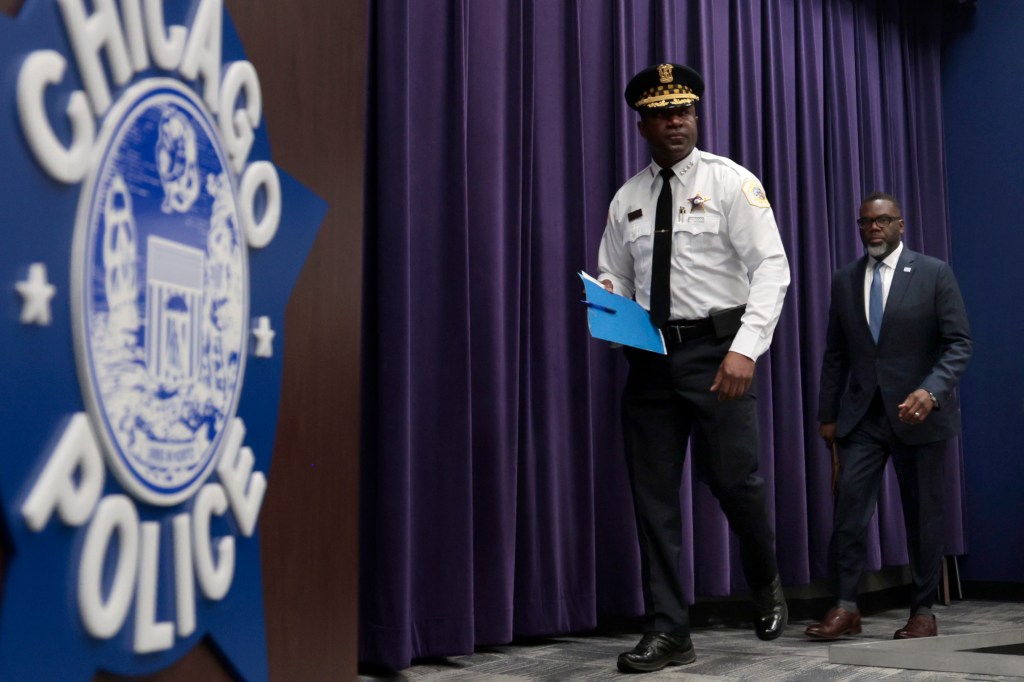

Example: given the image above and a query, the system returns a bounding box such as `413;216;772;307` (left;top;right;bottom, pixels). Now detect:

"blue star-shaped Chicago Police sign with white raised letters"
0;0;325;680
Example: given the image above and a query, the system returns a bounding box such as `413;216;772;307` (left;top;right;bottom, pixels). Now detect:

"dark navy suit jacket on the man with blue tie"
818;245;971;444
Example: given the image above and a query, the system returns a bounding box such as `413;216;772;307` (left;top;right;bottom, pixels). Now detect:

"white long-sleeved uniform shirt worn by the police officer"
598;150;790;359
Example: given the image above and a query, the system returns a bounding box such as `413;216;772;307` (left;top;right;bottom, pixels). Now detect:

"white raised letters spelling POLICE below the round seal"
22;413;266;653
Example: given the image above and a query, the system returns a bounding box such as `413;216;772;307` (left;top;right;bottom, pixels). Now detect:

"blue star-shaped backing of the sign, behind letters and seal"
0;0;327;680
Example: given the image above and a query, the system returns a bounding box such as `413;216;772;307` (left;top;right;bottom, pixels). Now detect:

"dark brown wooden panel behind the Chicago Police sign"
0;0;367;681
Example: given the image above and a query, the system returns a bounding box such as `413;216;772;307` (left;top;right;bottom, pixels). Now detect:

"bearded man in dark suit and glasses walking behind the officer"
806;193;971;640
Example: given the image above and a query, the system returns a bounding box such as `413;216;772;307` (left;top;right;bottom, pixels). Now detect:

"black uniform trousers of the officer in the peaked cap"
623;336;778;633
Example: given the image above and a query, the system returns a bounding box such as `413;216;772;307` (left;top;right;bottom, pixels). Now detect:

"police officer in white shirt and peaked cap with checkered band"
598;63;790;672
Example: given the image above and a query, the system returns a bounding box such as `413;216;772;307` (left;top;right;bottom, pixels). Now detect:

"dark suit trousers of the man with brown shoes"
828;393;946;614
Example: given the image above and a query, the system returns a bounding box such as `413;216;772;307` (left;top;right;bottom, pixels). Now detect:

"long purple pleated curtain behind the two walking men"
360;0;965;669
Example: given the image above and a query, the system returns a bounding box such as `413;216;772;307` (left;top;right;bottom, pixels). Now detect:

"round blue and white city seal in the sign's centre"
72;79;249;506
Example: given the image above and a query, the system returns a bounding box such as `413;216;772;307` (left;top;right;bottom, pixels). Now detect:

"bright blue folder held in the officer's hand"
580;272;666;355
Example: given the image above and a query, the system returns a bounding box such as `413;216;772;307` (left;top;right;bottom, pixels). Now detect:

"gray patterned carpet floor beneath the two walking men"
359;600;1024;682
